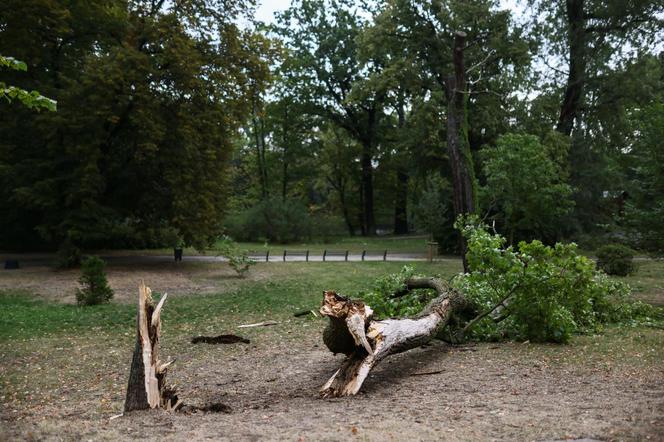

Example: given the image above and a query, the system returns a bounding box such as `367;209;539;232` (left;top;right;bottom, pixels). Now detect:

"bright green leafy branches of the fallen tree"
360;220;656;343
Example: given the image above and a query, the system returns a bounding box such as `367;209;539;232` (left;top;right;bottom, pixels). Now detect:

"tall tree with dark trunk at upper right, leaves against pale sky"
527;0;664;231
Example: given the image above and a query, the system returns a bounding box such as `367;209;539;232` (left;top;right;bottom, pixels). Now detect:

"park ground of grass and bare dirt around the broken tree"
0;261;664;440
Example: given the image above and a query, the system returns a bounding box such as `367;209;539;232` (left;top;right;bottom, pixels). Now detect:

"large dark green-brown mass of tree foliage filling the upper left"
0;0;270;254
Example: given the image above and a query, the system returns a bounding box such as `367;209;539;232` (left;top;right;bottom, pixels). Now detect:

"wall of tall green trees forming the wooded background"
0;0;664;258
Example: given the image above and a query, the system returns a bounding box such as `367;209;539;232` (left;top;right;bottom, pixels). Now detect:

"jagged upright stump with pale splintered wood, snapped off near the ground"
124;282;179;412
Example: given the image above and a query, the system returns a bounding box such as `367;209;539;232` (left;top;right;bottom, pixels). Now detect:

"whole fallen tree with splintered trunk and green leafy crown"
320;218;661;397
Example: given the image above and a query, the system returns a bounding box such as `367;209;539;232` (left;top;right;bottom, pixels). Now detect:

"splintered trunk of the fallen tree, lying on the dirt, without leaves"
320;278;465;397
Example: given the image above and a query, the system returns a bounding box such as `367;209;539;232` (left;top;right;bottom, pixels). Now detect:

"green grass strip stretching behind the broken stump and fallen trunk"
0;262;460;342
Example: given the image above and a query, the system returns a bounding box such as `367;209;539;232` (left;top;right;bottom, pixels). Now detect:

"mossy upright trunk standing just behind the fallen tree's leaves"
446;31;476;272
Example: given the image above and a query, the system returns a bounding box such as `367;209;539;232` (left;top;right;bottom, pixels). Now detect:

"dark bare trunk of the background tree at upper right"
556;0;587;136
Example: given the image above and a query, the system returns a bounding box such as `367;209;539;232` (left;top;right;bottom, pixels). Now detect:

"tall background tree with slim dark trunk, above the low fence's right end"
276;0;385;235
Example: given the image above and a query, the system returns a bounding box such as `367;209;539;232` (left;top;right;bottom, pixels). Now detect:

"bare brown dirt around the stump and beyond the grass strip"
0;260;664;441
